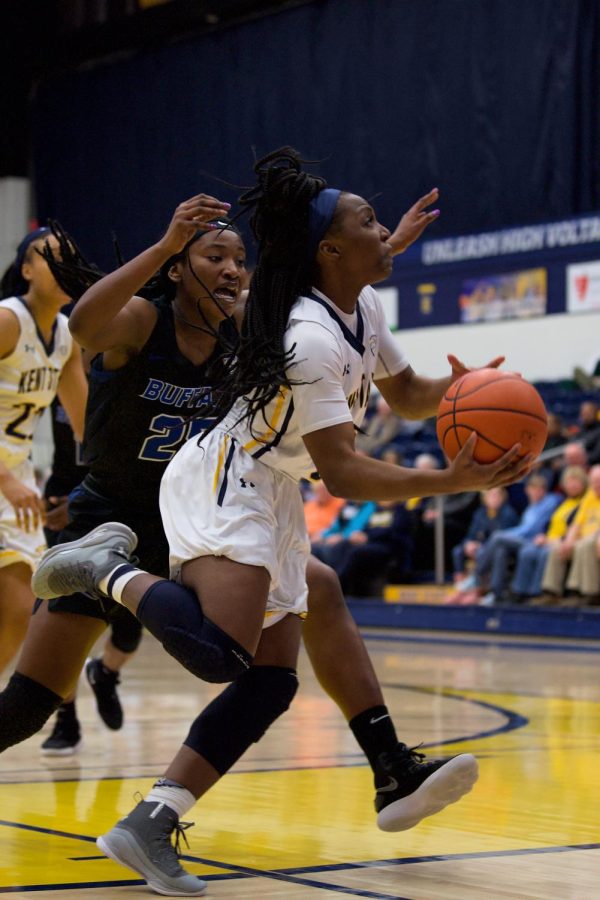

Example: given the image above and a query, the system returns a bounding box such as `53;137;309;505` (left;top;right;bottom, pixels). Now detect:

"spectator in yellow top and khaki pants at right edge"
542;465;600;606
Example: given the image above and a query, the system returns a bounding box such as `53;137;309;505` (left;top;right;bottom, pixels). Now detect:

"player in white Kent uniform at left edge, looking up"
0;228;87;672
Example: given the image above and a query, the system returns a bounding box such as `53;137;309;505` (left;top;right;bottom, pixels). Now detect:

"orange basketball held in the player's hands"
436;369;548;463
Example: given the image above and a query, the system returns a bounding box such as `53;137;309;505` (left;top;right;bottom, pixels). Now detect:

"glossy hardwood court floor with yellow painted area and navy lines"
0;631;600;900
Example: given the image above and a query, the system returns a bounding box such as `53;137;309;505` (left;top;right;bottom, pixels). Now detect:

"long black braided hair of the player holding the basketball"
202;147;327;434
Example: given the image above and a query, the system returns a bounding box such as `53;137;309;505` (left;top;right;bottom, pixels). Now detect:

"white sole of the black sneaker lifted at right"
377;753;479;831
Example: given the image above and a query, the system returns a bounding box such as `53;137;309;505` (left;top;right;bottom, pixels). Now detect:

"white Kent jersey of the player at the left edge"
0;297;73;469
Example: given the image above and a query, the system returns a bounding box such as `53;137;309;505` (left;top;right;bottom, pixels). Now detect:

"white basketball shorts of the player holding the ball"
160;429;310;627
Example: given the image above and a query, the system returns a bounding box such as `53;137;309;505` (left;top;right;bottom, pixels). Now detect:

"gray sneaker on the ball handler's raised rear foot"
31;522;137;600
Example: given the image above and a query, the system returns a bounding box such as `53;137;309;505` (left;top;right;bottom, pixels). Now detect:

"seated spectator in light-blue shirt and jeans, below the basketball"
457;473;561;606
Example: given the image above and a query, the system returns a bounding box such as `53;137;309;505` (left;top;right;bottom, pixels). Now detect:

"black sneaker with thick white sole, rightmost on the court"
375;744;478;831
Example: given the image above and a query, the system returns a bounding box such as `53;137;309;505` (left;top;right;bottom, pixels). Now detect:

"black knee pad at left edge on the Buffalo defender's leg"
0;672;63;752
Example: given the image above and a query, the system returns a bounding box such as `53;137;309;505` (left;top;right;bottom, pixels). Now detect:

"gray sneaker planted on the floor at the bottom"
96;800;206;897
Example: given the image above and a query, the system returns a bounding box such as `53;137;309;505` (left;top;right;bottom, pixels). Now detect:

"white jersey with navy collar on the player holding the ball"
221;287;408;481
